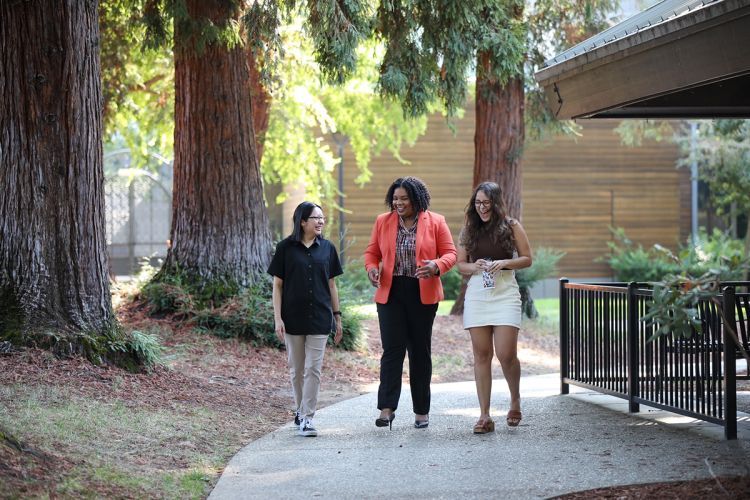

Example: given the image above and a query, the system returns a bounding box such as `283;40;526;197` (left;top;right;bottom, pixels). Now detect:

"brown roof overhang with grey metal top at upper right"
535;0;750;119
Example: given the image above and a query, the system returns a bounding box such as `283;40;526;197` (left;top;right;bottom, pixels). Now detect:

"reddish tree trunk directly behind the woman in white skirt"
451;54;525;314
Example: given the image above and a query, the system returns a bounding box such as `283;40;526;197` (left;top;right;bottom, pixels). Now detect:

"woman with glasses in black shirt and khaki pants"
268;201;343;437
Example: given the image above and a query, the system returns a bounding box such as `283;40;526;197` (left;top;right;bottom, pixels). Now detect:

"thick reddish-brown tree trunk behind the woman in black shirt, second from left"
164;0;271;286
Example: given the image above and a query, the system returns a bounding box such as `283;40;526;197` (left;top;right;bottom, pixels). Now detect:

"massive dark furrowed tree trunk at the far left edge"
0;0;114;344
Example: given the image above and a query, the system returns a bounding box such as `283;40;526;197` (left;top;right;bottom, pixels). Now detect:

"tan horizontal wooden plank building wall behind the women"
318;106;689;278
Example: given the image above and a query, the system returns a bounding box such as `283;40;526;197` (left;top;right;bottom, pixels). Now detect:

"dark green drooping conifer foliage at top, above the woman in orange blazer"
375;0;526;116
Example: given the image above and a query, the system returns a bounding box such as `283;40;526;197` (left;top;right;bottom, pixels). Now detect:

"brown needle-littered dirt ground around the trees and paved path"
0;308;750;499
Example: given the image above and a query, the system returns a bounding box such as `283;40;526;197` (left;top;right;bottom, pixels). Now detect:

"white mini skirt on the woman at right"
464;269;521;329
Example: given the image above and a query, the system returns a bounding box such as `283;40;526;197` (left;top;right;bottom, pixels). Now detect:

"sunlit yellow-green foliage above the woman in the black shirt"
261;26;427;204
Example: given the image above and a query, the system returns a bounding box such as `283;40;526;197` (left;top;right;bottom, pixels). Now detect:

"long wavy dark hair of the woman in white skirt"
459;182;516;258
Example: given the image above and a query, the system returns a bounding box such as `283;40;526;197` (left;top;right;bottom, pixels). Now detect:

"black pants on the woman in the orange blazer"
377;276;438;415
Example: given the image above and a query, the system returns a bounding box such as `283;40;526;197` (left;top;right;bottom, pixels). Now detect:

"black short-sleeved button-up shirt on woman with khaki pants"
268;237;344;335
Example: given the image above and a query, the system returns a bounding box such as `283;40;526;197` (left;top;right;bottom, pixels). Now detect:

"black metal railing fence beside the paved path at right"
560;279;750;439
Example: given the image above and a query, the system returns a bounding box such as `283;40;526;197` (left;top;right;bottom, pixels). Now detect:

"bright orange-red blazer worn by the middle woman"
364;210;456;304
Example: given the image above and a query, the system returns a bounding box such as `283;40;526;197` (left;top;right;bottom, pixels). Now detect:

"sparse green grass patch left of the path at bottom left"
0;384;236;498
